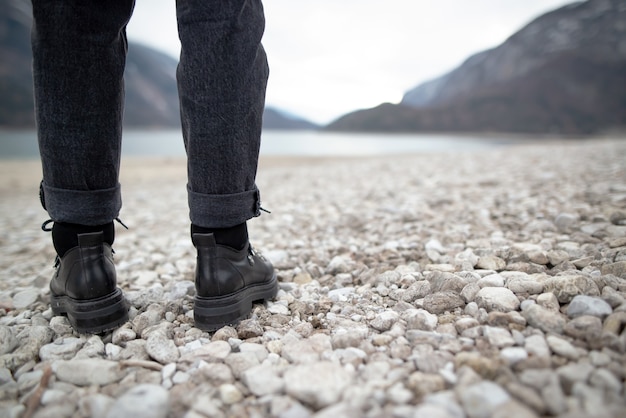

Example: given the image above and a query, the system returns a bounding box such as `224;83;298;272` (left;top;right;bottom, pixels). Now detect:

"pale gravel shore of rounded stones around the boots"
0;139;626;418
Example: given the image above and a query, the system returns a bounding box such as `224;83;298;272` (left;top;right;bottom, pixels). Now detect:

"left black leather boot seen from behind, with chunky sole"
50;232;128;334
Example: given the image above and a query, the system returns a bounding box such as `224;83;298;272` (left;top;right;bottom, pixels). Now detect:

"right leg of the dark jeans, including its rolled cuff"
177;0;268;228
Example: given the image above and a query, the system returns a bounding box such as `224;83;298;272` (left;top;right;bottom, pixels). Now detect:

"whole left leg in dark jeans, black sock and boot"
32;0;134;333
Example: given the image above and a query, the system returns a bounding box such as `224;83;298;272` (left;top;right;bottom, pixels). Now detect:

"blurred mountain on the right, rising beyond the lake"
329;0;626;134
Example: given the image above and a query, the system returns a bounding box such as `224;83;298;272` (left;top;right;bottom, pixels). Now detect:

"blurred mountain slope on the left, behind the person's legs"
0;0;316;129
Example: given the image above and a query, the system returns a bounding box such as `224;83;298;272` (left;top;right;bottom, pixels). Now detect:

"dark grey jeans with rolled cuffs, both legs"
32;0;269;228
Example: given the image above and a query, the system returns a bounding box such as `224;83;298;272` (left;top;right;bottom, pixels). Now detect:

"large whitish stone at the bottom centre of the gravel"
285;362;352;409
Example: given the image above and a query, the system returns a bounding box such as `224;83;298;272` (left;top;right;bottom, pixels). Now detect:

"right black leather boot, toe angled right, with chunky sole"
192;234;278;331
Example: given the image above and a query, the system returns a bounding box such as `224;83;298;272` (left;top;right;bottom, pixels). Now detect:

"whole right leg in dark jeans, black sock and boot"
177;0;278;331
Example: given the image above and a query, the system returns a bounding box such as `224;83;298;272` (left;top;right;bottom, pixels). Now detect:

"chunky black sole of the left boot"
50;288;128;334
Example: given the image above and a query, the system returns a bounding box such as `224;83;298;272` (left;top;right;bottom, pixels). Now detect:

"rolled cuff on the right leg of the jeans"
187;185;261;228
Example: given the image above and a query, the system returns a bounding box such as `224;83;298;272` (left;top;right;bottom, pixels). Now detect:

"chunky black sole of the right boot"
193;273;278;331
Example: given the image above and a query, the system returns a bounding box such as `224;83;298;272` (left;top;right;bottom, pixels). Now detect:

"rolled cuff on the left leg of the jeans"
41;183;122;225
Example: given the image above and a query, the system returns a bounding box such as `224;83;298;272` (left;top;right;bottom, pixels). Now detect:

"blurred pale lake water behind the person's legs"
0;130;520;159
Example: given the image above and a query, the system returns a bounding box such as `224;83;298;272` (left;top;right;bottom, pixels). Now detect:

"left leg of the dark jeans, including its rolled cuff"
32;0;134;225
